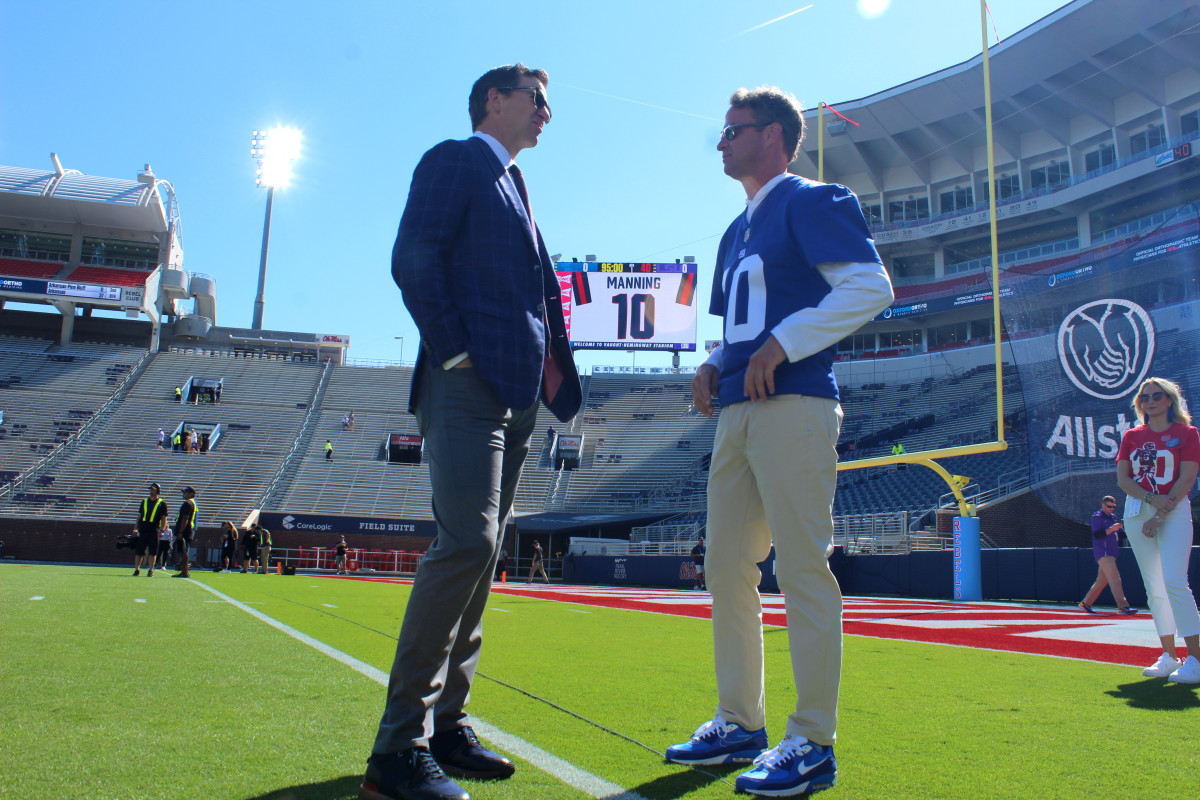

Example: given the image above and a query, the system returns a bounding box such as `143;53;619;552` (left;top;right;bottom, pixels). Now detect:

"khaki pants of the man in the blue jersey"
704;395;842;745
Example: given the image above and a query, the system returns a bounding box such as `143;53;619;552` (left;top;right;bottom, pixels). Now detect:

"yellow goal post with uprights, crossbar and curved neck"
817;0;1008;517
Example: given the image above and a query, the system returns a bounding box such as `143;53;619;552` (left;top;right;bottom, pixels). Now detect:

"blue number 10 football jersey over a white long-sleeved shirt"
709;175;880;405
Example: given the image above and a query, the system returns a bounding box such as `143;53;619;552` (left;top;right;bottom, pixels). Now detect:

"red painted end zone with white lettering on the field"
336;578;1160;667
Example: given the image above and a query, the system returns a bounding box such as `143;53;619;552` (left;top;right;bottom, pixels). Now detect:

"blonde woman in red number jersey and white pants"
1117;378;1200;684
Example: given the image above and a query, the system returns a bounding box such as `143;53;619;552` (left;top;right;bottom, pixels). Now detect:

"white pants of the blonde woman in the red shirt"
1126;497;1200;636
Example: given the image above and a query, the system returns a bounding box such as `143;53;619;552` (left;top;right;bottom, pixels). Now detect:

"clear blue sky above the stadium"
0;0;1062;366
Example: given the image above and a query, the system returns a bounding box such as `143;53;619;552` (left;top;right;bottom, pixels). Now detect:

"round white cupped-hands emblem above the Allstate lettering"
1058;297;1154;399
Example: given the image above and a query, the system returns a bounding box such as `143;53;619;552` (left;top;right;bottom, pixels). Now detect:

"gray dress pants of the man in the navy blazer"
372;363;538;753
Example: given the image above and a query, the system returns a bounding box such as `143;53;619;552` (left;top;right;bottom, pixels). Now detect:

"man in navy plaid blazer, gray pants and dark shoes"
359;64;582;800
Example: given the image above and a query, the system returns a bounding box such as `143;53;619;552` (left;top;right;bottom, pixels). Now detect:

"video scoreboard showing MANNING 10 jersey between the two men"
556;261;697;351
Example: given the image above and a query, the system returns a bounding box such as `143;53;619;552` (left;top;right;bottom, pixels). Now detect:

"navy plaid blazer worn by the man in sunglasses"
391;137;583;422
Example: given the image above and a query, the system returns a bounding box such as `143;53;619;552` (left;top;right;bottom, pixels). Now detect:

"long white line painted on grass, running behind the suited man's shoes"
189;578;646;800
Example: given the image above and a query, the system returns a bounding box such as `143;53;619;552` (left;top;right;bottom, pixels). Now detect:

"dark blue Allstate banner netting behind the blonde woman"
1002;206;1200;522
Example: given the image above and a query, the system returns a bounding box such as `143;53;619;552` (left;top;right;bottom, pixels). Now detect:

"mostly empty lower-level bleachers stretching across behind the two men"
0;326;1046;541
